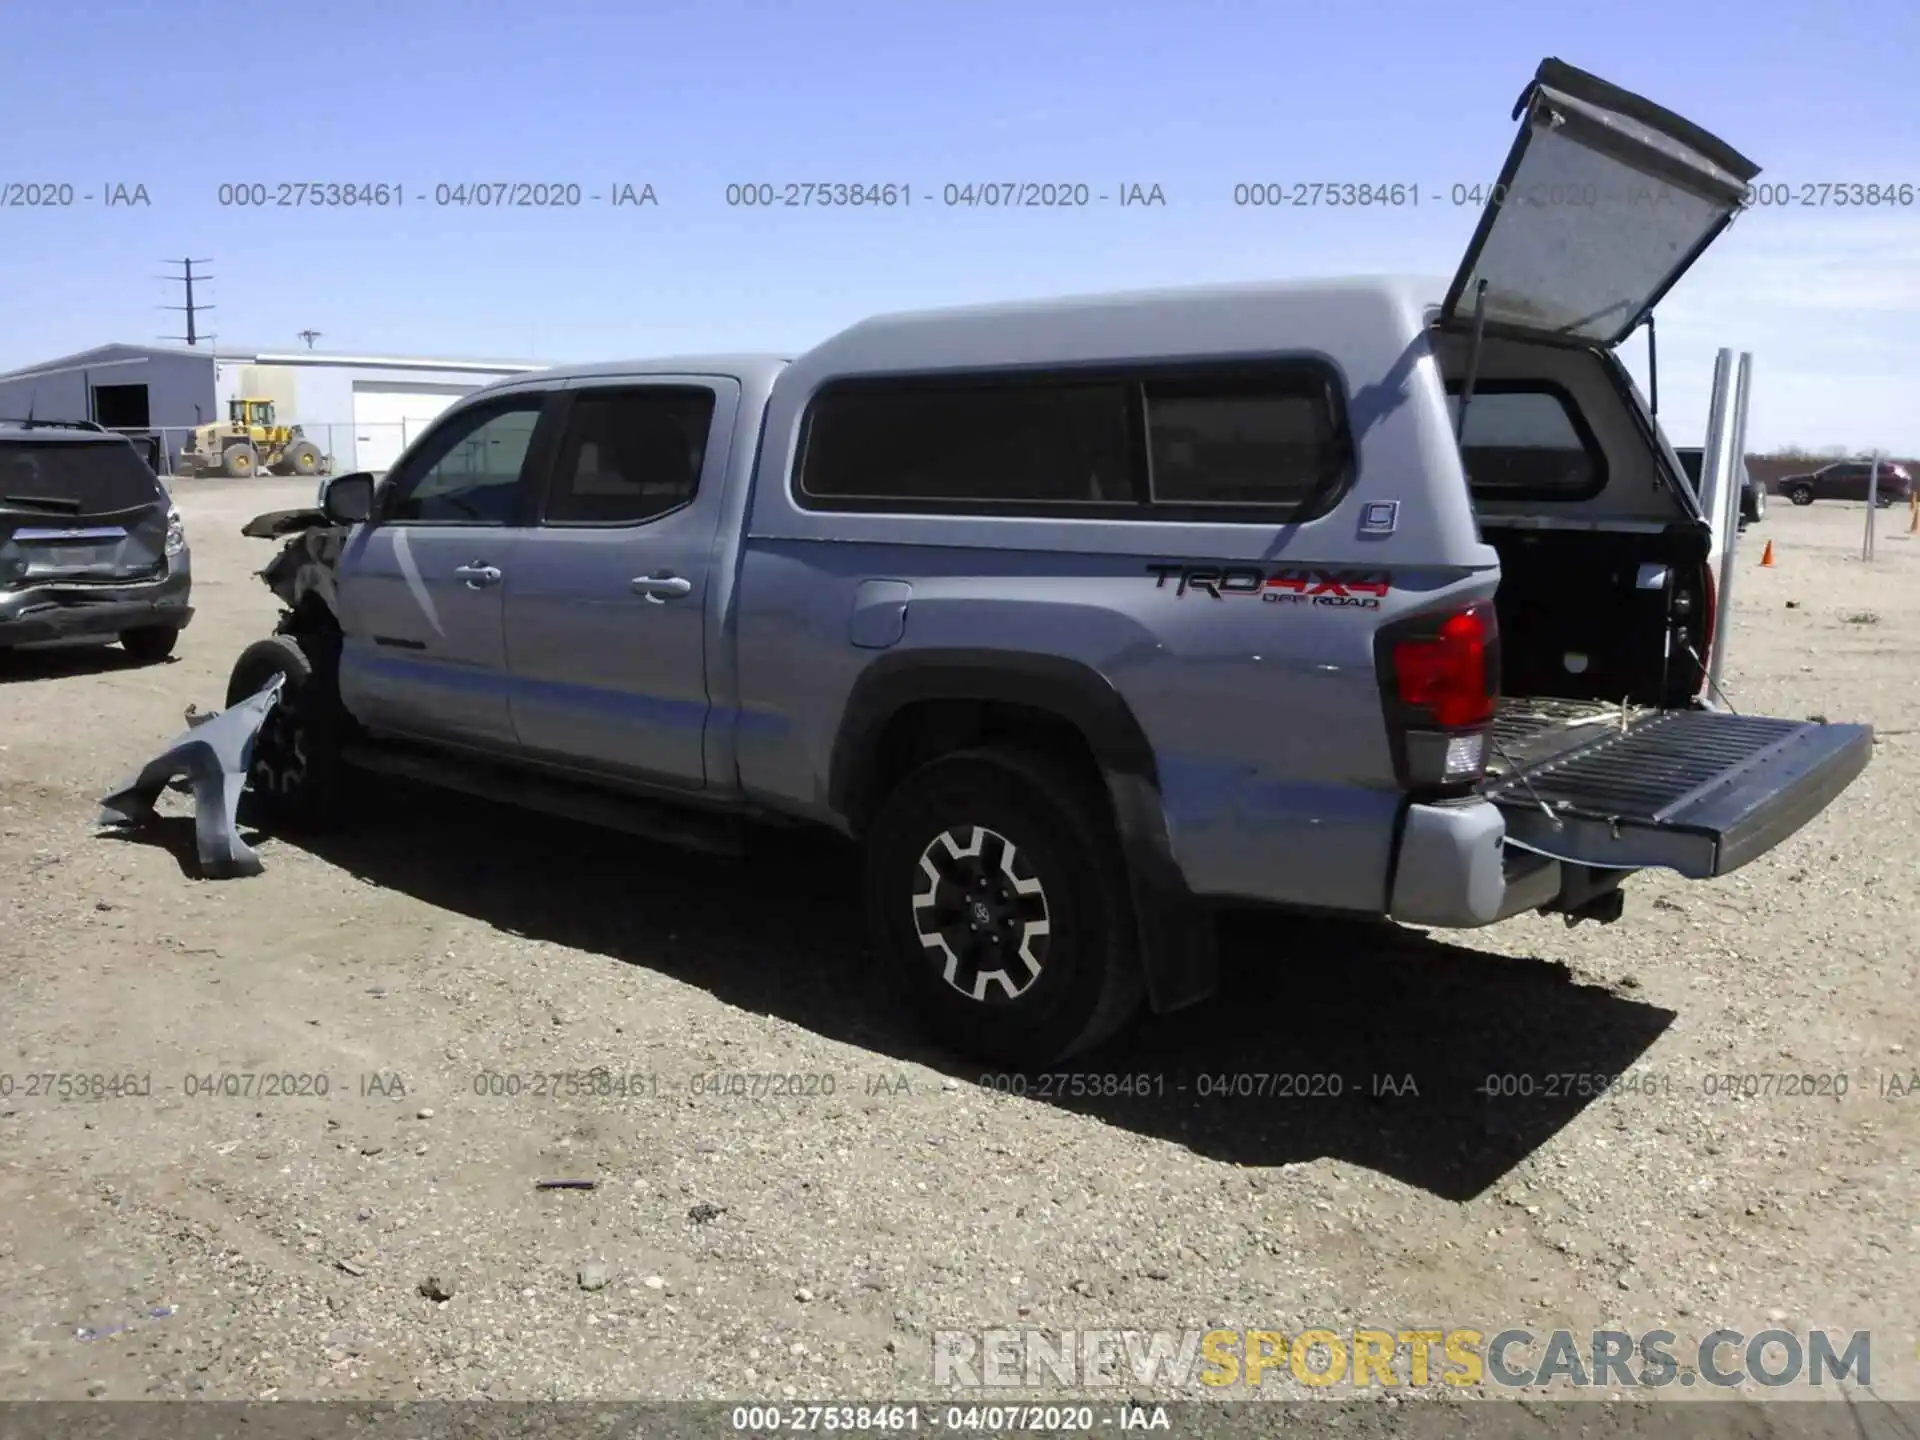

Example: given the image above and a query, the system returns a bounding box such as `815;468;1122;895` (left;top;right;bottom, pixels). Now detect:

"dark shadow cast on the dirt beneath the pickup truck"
116;785;1674;1200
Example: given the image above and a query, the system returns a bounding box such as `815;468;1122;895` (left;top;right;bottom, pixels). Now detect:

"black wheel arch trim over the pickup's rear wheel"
828;649;1219;1014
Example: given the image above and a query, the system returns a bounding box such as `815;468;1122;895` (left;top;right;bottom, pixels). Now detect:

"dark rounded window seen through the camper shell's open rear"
1448;386;1607;501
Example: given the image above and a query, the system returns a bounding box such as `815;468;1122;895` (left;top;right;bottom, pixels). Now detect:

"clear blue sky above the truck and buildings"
0;0;1920;455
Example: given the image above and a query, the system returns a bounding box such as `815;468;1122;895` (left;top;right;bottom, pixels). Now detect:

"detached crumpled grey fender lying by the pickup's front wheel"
96;674;286;879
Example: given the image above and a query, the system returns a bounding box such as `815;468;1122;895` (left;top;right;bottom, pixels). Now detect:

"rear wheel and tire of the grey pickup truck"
866;749;1144;1069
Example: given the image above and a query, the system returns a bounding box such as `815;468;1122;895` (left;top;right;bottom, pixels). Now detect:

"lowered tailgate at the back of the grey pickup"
1480;710;1874;879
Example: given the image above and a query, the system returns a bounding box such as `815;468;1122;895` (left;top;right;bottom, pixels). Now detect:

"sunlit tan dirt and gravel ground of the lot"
0;480;1920;1400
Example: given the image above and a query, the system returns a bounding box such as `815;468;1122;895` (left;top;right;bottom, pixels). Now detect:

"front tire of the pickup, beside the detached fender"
227;636;346;828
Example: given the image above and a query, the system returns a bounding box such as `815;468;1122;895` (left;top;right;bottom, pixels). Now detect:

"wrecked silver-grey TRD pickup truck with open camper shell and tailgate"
230;60;1872;1066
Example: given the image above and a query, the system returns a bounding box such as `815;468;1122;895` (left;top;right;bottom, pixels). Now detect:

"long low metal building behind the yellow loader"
0;344;545;474
